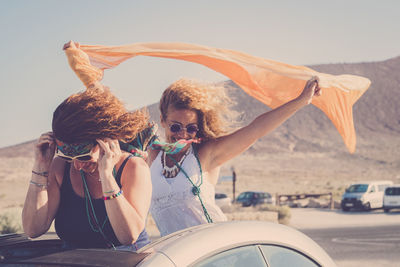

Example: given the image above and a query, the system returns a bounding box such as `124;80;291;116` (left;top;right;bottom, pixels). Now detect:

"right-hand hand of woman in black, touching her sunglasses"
96;138;122;177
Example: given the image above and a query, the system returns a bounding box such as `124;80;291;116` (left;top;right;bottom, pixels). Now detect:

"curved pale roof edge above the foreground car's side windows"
140;221;336;267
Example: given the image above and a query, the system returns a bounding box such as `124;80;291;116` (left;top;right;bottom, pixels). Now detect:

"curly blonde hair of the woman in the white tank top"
159;79;232;141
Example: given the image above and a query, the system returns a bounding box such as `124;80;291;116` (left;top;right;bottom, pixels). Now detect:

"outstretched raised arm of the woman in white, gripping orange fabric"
200;77;321;171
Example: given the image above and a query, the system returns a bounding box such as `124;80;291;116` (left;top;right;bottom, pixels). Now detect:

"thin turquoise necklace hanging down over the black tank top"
79;171;116;250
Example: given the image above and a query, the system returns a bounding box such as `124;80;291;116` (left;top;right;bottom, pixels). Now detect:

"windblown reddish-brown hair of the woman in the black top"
52;88;148;143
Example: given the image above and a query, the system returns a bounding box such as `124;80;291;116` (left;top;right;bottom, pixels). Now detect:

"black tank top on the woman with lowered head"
55;155;137;248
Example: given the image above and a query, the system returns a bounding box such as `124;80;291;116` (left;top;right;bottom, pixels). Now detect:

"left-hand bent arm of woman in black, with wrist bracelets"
22;132;62;237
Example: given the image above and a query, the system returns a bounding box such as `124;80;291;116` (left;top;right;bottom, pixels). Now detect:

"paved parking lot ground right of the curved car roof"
290;209;400;267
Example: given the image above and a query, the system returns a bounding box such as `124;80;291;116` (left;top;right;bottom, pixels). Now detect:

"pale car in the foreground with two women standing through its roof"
0;221;336;267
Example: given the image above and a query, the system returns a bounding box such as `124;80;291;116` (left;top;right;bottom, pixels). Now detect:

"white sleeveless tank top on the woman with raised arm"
150;149;226;236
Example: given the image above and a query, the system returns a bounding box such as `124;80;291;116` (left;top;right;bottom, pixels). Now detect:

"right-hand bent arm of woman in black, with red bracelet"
97;139;152;245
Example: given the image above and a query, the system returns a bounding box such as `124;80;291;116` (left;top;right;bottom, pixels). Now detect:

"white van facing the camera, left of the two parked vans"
341;181;393;211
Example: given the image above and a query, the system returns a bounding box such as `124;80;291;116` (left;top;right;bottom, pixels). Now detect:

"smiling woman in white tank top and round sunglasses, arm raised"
150;77;321;235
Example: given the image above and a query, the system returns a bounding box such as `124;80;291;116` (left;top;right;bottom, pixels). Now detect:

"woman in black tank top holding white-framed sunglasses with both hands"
22;74;152;250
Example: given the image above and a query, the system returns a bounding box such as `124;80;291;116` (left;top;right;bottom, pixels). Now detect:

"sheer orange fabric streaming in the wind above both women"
66;43;371;153
